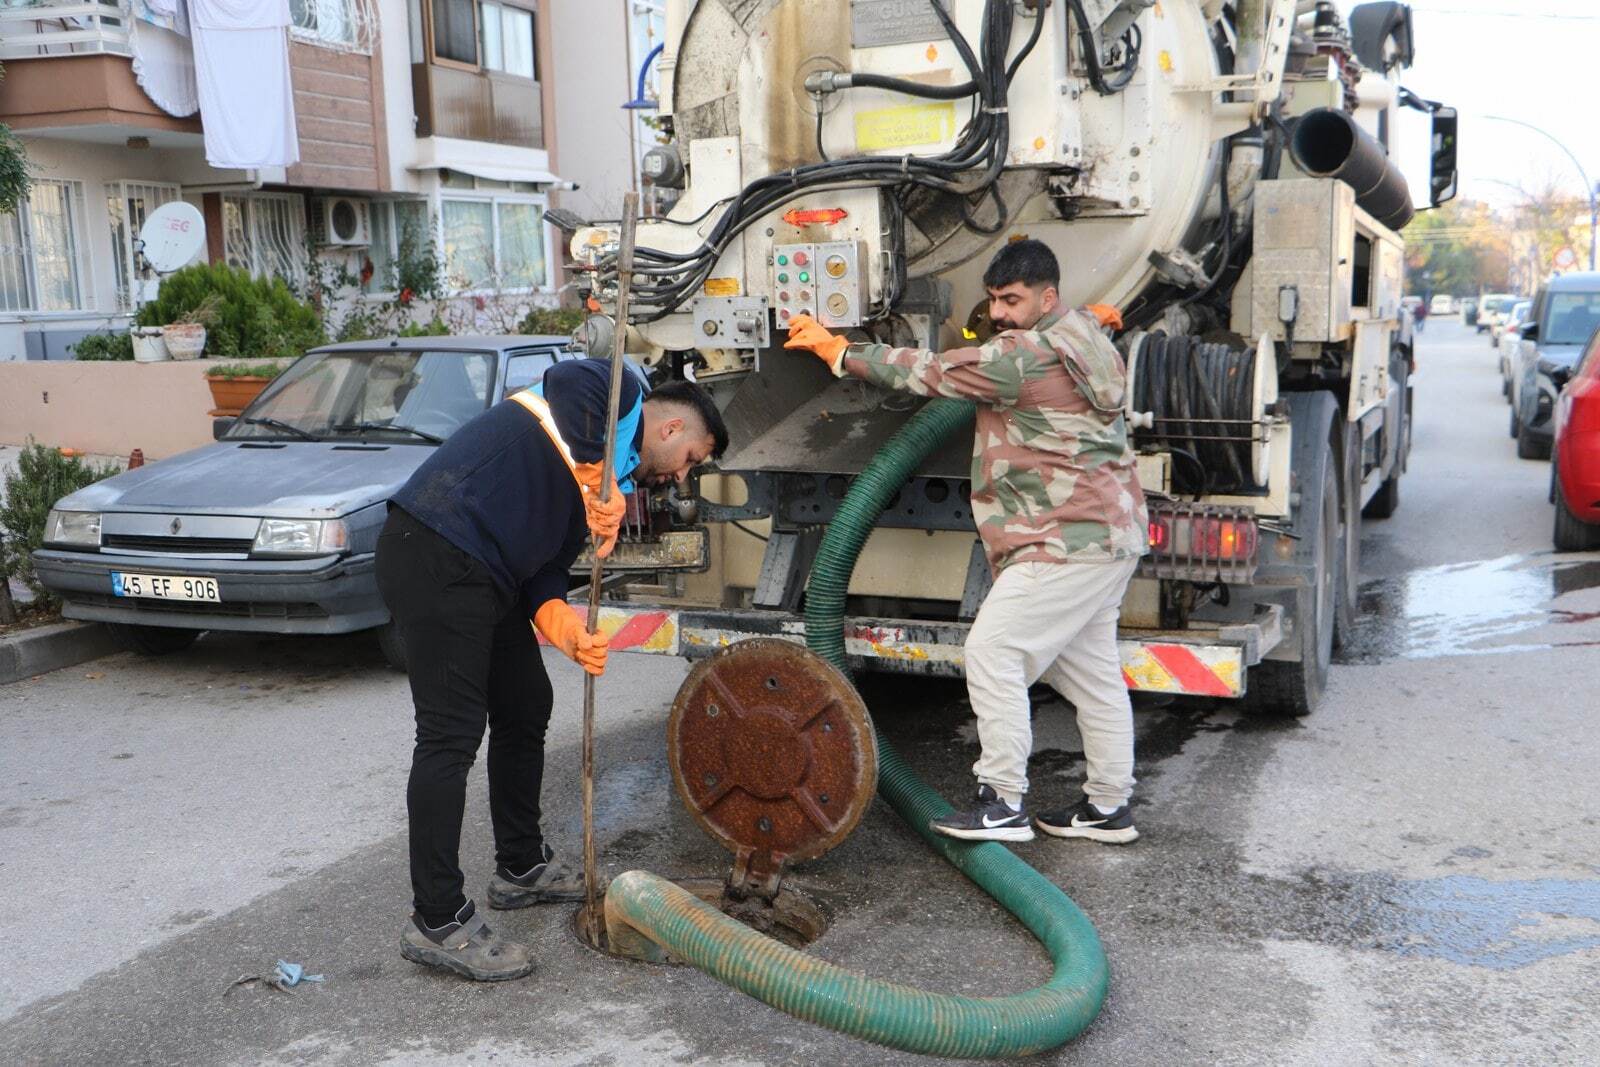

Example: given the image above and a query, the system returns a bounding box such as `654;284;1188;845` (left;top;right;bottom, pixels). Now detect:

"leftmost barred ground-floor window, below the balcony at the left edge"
0;178;83;312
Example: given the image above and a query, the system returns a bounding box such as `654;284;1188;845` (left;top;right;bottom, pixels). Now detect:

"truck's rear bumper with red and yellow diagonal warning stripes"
563;605;1283;697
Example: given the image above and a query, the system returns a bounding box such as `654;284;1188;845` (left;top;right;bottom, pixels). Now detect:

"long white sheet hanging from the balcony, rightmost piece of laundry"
189;0;299;170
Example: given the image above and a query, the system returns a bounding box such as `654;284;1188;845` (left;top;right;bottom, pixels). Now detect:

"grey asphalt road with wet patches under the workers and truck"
0;322;1600;1067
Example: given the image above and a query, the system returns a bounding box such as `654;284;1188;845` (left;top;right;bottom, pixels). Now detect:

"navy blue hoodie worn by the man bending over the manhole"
394;360;645;616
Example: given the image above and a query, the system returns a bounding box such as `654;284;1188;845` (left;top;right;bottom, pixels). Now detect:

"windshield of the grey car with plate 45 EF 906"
227;349;494;443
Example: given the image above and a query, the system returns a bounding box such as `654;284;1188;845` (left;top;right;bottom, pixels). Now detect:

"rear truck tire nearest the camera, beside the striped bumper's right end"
1245;462;1342;718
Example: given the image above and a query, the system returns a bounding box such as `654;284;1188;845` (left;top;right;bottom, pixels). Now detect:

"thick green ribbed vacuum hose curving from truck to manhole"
605;400;1110;1057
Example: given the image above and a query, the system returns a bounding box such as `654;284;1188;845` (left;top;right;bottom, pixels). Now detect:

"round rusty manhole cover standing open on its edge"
667;637;878;888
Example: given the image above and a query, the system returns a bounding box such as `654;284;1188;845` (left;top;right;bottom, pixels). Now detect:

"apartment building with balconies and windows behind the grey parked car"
0;0;662;360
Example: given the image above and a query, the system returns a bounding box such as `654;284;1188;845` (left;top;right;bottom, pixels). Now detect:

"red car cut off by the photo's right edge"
1550;330;1600;552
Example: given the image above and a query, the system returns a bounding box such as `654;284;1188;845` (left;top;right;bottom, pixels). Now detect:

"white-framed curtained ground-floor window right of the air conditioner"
440;198;549;290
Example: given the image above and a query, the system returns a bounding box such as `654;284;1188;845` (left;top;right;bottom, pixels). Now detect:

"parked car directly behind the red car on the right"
1510;270;1600;459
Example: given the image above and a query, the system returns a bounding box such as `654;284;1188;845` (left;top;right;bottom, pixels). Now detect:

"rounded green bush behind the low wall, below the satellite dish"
136;264;326;358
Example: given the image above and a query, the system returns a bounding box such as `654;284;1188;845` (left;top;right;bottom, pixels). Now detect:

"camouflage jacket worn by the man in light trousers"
840;312;1147;573
